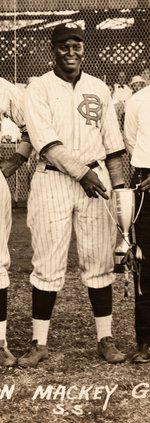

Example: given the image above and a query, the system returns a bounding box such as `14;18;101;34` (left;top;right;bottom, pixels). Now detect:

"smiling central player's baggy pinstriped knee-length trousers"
27;167;116;291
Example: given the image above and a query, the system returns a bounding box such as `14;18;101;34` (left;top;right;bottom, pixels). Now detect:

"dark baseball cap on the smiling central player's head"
52;22;85;44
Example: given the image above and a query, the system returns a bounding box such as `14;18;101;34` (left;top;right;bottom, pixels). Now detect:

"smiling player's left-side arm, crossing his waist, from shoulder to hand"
24;81;108;198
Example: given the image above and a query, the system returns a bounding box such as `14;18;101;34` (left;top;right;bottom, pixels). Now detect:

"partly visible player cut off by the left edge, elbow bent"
0;78;32;366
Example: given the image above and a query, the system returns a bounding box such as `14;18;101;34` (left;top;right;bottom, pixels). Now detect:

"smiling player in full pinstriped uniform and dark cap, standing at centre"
18;23;125;367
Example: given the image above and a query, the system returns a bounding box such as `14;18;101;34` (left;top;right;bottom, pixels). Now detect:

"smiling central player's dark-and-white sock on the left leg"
32;287;57;345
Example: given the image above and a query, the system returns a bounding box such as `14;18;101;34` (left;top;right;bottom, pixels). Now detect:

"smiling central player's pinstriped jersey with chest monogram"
25;71;124;164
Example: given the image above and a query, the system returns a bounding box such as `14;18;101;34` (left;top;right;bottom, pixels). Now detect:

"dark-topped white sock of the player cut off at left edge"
0;288;7;347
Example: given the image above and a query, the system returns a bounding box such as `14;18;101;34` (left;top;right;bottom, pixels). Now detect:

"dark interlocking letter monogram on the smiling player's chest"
78;94;102;127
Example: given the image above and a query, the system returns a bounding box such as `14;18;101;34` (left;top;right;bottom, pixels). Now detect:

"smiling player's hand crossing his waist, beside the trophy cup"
80;169;109;200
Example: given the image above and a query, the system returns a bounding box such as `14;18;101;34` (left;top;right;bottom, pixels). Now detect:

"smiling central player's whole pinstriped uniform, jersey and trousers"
25;71;124;291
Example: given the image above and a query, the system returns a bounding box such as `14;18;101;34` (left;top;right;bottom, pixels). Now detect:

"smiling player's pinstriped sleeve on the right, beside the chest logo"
99;89;125;155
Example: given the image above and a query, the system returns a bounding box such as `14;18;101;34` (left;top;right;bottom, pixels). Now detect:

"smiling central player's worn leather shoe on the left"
18;340;48;367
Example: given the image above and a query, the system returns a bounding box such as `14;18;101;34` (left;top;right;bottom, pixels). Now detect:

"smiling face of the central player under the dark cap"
54;39;84;73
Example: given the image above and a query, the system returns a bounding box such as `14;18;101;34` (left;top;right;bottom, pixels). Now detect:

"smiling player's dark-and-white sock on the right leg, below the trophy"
88;285;112;342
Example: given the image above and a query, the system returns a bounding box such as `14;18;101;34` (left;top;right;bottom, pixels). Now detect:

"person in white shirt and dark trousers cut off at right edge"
125;85;150;364
